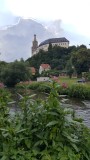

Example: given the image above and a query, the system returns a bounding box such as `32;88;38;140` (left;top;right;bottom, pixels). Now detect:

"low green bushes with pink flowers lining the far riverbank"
17;82;90;100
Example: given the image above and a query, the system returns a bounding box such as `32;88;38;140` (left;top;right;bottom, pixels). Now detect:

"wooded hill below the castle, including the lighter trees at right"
27;45;90;76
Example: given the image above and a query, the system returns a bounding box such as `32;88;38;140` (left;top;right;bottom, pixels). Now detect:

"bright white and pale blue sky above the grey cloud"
0;0;90;43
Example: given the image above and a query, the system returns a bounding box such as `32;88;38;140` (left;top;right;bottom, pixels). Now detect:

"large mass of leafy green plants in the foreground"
0;82;90;160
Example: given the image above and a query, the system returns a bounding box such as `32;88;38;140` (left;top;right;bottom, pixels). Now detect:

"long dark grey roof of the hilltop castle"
39;37;69;47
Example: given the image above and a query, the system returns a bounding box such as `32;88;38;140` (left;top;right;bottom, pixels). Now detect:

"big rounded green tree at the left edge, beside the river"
1;60;31;87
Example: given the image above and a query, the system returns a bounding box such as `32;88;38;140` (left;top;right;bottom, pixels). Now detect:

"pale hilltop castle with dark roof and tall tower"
32;35;69;56
